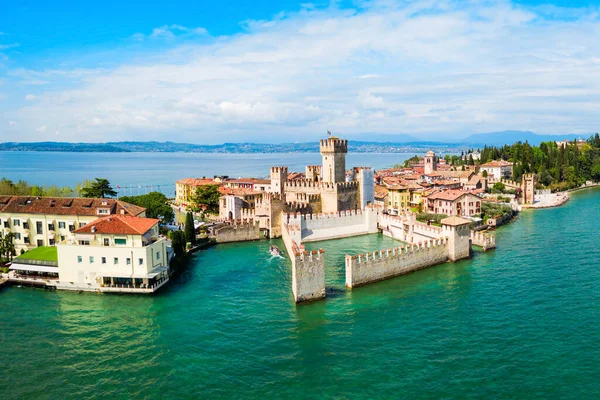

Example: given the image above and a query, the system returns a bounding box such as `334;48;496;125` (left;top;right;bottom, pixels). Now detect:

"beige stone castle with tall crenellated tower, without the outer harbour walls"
219;136;375;237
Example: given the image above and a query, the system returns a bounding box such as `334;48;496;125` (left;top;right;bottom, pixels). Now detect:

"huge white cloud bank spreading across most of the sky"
0;0;600;142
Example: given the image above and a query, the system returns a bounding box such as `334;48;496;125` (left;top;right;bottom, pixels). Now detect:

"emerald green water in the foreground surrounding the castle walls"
0;190;600;399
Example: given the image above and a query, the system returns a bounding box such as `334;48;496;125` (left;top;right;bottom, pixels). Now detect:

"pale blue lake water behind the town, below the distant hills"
0;151;415;197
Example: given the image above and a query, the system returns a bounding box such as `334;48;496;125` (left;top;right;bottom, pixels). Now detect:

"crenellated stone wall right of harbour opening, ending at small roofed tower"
346;238;449;288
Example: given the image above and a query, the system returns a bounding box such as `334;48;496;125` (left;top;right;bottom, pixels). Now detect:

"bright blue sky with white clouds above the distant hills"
0;0;600;144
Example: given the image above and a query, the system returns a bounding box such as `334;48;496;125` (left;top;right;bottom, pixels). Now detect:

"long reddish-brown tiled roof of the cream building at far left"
0;196;146;216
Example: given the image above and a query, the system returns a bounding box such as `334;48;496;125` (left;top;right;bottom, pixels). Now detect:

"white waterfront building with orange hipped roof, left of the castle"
56;215;169;292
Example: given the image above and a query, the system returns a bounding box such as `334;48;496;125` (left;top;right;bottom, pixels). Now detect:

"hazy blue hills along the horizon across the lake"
0;131;589;153
